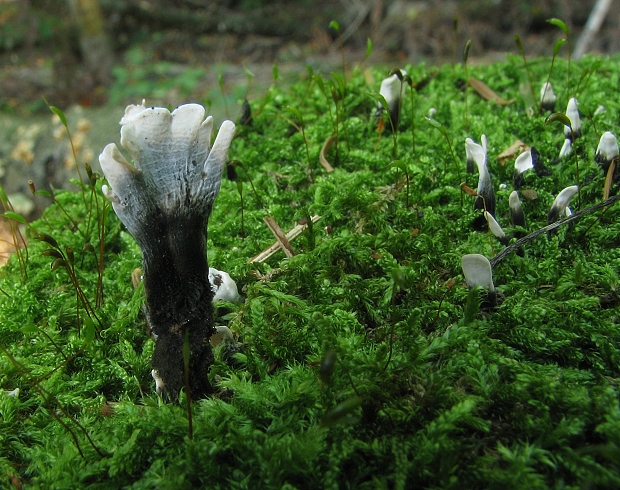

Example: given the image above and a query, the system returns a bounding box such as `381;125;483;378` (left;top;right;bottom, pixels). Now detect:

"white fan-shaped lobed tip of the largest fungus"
99;101;235;249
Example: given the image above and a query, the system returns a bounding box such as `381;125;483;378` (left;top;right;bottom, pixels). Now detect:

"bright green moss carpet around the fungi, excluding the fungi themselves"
0;57;620;488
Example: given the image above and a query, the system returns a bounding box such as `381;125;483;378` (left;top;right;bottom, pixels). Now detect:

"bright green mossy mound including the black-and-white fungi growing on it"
0;51;620;489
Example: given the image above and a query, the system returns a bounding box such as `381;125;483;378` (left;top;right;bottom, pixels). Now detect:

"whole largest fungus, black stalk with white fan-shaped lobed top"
99;104;235;399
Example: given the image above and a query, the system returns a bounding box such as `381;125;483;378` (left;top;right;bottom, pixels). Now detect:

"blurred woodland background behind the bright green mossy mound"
0;0;620;260
